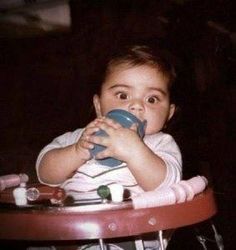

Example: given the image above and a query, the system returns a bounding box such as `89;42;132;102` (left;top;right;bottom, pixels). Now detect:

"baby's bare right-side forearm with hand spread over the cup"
88;119;181;190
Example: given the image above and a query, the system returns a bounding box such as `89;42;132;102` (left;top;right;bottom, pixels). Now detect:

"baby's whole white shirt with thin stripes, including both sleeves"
36;129;182;199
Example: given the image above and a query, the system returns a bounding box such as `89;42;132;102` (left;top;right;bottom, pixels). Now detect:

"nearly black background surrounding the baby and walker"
0;0;236;249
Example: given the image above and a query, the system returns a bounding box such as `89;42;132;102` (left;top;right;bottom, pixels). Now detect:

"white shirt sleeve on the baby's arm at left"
36;129;83;186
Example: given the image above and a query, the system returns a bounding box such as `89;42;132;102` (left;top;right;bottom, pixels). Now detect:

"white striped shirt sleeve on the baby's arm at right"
145;132;182;189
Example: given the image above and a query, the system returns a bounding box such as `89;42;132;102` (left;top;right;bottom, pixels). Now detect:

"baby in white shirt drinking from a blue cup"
36;46;182;249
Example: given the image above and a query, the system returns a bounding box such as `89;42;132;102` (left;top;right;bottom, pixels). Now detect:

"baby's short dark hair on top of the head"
98;45;176;95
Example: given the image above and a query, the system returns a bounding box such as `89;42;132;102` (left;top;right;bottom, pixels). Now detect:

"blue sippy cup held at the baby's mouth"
90;109;147;167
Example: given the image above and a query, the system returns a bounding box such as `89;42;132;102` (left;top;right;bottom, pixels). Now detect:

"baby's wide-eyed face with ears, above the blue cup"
94;64;175;134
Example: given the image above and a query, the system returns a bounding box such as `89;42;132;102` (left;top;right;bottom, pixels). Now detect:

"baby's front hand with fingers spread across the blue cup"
89;117;142;161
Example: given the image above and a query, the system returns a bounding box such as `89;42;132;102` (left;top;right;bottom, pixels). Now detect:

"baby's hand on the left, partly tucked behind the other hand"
75;118;101;161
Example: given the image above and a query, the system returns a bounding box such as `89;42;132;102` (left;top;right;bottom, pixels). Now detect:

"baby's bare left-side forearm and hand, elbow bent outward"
37;119;98;185
